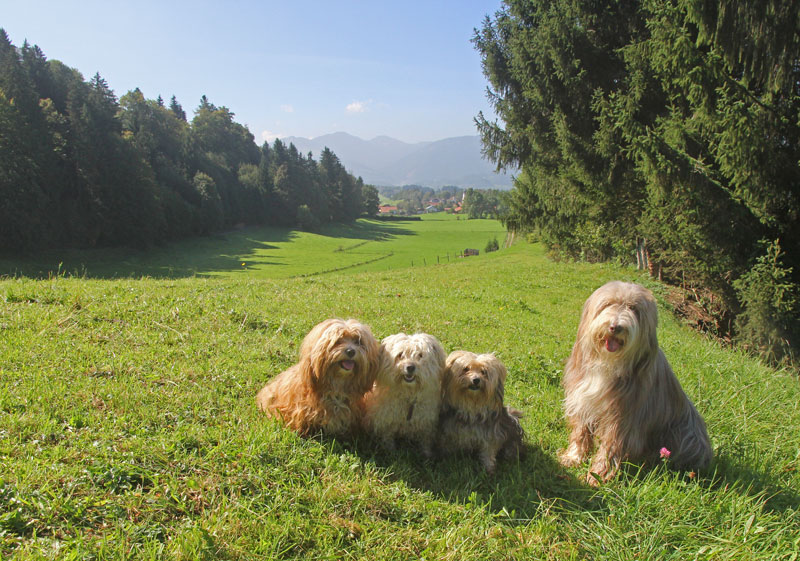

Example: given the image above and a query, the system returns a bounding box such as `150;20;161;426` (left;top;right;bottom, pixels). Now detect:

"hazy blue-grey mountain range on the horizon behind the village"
281;132;511;189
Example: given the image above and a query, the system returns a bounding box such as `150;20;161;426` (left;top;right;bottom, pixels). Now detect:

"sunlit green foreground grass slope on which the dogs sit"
0;240;800;561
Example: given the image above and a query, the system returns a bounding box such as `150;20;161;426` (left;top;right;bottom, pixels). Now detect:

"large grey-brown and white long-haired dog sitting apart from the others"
560;281;711;485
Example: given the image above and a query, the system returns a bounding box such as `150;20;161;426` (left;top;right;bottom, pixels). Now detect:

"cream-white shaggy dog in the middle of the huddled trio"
364;333;445;457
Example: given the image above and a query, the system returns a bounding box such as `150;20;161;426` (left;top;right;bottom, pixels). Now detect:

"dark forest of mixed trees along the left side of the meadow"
0;29;378;252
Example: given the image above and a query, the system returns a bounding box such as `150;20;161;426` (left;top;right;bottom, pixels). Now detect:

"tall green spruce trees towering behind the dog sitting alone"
473;0;800;362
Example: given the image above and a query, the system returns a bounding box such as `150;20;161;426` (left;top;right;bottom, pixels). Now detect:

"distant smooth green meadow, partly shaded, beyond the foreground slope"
0;213;505;279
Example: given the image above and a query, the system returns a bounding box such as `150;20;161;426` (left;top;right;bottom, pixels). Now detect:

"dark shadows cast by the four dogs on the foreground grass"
334;439;800;525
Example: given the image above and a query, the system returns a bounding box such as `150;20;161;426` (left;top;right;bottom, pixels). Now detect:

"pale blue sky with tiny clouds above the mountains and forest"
6;0;501;143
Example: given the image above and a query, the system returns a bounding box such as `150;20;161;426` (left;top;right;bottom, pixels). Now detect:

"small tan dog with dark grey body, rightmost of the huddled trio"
439;351;525;473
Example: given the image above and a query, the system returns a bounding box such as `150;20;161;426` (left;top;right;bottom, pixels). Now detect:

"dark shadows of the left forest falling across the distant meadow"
0;220;416;279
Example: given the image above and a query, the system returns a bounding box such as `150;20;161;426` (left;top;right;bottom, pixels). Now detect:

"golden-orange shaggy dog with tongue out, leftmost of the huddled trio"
256;319;380;436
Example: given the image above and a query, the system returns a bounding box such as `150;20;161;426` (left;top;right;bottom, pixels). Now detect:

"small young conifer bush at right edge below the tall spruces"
733;240;800;365
